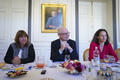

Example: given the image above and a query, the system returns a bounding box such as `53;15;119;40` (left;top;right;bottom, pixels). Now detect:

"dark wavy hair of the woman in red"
92;29;109;45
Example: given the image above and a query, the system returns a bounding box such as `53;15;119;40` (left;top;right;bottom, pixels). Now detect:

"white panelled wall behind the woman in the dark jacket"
0;0;28;60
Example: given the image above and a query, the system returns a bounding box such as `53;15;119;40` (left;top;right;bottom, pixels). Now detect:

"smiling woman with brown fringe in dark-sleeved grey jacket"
4;30;35;64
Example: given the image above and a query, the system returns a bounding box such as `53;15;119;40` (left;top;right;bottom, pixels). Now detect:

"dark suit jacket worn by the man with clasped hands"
50;39;79;62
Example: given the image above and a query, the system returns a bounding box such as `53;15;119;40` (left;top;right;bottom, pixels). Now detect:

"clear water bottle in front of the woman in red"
93;47;100;67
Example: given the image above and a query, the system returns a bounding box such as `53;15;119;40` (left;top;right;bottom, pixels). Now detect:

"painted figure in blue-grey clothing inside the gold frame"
45;8;63;29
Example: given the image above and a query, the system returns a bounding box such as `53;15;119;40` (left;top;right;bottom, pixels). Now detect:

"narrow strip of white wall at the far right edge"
116;0;120;48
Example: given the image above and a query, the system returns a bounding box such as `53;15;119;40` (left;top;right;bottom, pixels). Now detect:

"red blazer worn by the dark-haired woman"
89;42;118;62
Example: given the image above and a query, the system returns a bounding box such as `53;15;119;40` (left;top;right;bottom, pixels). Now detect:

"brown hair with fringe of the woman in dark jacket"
15;30;29;48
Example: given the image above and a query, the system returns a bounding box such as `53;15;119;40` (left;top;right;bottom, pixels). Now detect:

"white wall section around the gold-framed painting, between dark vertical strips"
31;0;75;60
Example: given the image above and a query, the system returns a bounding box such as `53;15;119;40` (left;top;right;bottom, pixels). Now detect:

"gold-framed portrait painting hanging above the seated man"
41;4;66;33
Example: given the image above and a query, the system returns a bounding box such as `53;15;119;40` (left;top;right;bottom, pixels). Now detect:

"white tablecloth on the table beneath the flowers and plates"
0;63;119;80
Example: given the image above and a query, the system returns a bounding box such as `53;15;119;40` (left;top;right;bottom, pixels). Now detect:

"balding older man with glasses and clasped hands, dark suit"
50;27;79;62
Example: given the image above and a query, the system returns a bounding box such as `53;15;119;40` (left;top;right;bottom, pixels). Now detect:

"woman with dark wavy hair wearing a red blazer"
89;29;118;62
